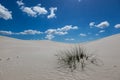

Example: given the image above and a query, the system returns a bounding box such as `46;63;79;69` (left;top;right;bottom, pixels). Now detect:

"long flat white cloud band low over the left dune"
0;29;42;35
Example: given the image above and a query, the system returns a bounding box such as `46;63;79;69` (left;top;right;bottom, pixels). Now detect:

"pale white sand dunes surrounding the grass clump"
0;34;120;80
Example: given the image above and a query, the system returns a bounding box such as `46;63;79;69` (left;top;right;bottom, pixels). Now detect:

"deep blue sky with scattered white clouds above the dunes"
0;0;120;42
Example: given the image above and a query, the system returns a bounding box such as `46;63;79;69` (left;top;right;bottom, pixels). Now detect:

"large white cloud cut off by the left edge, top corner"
0;4;12;20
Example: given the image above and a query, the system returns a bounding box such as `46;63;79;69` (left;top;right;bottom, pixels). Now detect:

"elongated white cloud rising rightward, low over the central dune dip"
45;25;78;39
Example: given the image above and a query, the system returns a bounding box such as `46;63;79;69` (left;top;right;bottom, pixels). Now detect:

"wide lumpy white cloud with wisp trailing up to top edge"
16;1;48;17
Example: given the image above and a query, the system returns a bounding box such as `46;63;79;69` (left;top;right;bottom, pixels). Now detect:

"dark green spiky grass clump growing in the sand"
57;45;98;72
